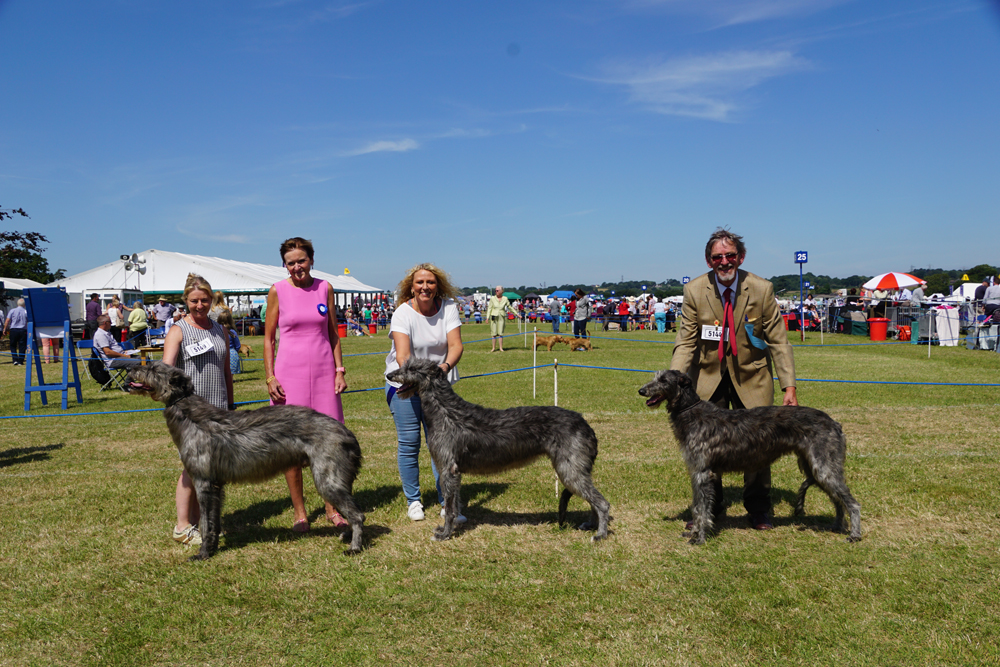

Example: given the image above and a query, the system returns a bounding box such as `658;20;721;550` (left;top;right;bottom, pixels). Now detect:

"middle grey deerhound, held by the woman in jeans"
386;357;611;541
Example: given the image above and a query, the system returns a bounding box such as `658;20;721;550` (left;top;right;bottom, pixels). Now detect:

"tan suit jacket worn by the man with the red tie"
670;270;795;408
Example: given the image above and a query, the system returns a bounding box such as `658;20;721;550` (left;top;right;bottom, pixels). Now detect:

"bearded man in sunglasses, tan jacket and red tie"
670;228;798;530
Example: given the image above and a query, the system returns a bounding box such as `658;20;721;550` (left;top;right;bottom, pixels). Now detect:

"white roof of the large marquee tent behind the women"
52;250;385;294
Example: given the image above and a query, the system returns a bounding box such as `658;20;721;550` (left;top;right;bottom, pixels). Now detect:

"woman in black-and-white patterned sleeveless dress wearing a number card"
163;273;233;546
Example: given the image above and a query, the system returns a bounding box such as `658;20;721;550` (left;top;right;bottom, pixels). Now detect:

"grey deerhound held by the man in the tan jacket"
639;371;861;544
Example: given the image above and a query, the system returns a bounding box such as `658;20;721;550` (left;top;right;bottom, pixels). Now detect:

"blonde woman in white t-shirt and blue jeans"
385;264;465;523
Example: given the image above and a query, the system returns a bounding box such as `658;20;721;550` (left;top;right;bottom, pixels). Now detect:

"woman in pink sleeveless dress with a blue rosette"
264;237;347;533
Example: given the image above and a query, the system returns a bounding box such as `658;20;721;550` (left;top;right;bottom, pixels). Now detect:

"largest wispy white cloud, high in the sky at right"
592;51;808;121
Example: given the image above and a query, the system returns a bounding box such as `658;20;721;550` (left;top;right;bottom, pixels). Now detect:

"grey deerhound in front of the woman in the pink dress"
128;362;365;560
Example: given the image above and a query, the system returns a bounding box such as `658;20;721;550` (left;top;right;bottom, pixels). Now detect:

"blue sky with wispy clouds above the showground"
0;0;1000;287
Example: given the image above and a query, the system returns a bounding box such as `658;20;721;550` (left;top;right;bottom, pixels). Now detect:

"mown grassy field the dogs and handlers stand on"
0;326;1000;665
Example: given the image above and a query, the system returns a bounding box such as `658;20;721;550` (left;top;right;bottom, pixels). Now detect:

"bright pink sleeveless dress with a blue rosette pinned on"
272;278;344;423
